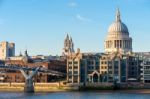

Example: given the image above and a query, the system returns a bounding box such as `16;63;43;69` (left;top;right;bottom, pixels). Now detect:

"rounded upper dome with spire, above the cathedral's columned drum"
108;9;128;33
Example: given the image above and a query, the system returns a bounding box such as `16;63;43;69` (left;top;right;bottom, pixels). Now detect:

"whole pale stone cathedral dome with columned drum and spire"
104;9;132;54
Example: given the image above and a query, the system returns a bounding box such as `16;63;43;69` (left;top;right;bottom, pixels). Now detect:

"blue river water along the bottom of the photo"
0;91;150;99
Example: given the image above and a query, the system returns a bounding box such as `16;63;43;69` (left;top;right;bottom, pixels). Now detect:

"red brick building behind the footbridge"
0;60;66;82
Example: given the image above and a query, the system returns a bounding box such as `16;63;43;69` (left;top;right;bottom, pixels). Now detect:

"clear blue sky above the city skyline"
0;0;150;55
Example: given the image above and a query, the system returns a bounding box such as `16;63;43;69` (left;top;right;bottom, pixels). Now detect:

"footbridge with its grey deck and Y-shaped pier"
0;65;65;93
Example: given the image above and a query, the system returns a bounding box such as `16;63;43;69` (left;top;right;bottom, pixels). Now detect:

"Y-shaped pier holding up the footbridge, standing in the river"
20;67;40;93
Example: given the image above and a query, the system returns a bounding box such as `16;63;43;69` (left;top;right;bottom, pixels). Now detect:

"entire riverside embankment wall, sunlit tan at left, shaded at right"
0;82;150;92
